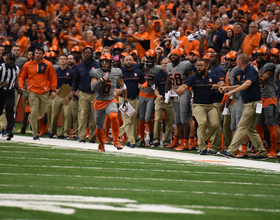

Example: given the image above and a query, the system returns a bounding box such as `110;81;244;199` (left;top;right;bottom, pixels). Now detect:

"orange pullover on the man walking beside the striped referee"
18;59;57;94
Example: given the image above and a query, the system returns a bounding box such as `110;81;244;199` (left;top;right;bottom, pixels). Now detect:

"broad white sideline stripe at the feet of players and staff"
2;135;280;173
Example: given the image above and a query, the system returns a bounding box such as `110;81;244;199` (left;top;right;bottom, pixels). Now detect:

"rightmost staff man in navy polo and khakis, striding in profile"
219;53;268;159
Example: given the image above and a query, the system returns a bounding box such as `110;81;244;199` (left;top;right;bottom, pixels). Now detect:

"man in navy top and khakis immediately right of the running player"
117;55;146;148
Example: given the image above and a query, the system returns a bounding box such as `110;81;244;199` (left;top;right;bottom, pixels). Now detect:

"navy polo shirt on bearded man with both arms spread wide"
184;73;220;104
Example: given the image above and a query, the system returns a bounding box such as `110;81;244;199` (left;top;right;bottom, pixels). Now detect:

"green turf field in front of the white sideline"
0;141;280;220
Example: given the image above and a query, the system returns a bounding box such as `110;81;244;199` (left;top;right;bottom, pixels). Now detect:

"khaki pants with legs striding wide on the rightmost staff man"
227;101;267;157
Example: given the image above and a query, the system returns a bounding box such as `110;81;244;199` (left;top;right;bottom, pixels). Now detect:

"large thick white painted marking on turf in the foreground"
0;193;204;215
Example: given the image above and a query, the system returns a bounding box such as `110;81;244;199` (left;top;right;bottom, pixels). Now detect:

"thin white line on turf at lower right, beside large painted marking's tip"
179;205;280;212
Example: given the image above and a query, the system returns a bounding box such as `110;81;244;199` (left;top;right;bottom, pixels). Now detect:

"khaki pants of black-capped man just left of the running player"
79;91;96;141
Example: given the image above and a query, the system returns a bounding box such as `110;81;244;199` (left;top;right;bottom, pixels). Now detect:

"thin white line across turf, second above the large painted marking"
0;173;280;186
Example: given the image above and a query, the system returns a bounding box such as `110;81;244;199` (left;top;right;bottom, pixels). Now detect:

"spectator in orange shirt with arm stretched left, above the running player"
127;24;149;58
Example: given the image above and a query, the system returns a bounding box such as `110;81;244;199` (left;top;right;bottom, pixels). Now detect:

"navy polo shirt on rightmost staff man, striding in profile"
239;64;261;104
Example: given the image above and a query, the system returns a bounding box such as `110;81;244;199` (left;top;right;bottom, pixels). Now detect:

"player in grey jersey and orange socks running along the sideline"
90;53;128;152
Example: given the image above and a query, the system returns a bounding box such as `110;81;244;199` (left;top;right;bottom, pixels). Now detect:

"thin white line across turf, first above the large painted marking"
0;184;280;198
